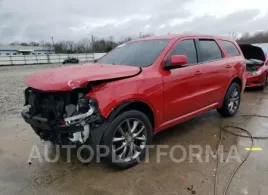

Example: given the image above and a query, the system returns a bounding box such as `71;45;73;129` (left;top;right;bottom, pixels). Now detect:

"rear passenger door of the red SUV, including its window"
195;38;228;109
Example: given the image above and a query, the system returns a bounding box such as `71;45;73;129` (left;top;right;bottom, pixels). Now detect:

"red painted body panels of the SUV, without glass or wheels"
26;35;246;133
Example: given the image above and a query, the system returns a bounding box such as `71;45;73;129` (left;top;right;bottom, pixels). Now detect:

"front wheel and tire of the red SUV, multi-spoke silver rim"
102;110;152;169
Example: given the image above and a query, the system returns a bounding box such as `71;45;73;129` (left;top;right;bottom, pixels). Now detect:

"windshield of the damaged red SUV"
98;39;169;67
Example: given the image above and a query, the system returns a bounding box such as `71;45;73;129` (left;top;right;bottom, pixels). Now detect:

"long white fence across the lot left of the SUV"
0;53;105;66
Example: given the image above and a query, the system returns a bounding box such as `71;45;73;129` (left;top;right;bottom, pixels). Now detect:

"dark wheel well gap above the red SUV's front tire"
110;101;155;128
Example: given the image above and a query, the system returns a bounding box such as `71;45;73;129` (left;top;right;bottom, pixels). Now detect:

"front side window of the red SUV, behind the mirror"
168;40;197;65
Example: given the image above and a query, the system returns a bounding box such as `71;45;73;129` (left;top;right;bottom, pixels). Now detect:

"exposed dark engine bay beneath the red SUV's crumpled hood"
25;88;93;120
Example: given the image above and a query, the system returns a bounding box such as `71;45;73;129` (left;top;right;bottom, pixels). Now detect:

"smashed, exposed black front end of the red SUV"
21;88;104;145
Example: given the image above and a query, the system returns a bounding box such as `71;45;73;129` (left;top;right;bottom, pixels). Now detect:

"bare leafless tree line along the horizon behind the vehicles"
9;31;268;53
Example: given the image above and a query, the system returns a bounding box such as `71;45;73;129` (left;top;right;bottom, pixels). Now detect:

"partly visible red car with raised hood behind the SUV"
239;44;268;90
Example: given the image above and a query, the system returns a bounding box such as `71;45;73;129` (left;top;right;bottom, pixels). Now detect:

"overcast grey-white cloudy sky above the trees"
0;0;268;43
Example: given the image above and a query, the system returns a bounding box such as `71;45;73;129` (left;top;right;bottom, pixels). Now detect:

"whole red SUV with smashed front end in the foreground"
22;35;246;168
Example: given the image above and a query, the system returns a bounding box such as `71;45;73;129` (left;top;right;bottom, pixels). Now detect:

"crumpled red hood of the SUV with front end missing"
25;63;141;91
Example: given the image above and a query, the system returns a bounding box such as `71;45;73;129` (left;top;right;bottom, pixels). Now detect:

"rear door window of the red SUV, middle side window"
199;39;222;62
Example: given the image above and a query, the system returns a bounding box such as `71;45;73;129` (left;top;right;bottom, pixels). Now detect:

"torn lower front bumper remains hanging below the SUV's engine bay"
21;111;108;148
